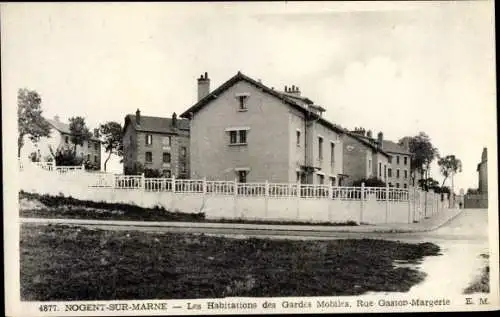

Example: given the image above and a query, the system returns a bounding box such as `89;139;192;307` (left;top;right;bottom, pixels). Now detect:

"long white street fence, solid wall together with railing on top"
22;160;449;224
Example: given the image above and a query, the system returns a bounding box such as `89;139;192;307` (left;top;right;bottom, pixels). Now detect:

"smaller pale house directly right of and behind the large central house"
343;129;390;185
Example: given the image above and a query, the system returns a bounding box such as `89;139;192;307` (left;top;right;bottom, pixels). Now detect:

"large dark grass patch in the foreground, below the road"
20;224;440;301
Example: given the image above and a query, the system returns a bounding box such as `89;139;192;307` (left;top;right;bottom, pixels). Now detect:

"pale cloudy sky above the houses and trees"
1;1;496;190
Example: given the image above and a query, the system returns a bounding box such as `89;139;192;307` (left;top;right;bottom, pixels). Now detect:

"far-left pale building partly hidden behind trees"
21;116;101;170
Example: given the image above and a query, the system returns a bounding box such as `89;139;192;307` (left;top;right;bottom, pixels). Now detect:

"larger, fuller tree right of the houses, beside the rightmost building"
399;132;439;189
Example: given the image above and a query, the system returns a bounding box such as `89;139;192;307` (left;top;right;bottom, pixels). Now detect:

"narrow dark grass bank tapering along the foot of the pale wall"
19;191;357;226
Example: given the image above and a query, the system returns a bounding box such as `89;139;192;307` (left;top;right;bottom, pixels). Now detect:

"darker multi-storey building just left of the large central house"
123;109;190;178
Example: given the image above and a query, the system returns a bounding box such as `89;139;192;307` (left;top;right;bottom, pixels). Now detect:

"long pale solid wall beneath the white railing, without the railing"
20;164;446;224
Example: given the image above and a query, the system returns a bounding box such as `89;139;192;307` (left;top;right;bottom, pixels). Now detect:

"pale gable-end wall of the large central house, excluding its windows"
190;81;295;182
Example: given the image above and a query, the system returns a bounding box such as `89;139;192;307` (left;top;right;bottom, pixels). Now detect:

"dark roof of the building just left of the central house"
123;114;189;133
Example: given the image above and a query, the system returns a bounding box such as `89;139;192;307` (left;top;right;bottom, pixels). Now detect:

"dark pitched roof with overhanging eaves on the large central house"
180;72;344;133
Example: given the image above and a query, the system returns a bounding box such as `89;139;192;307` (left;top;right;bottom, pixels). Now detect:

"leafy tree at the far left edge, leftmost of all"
17;88;50;157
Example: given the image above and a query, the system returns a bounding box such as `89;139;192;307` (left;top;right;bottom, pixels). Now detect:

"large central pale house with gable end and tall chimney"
181;72;344;181
